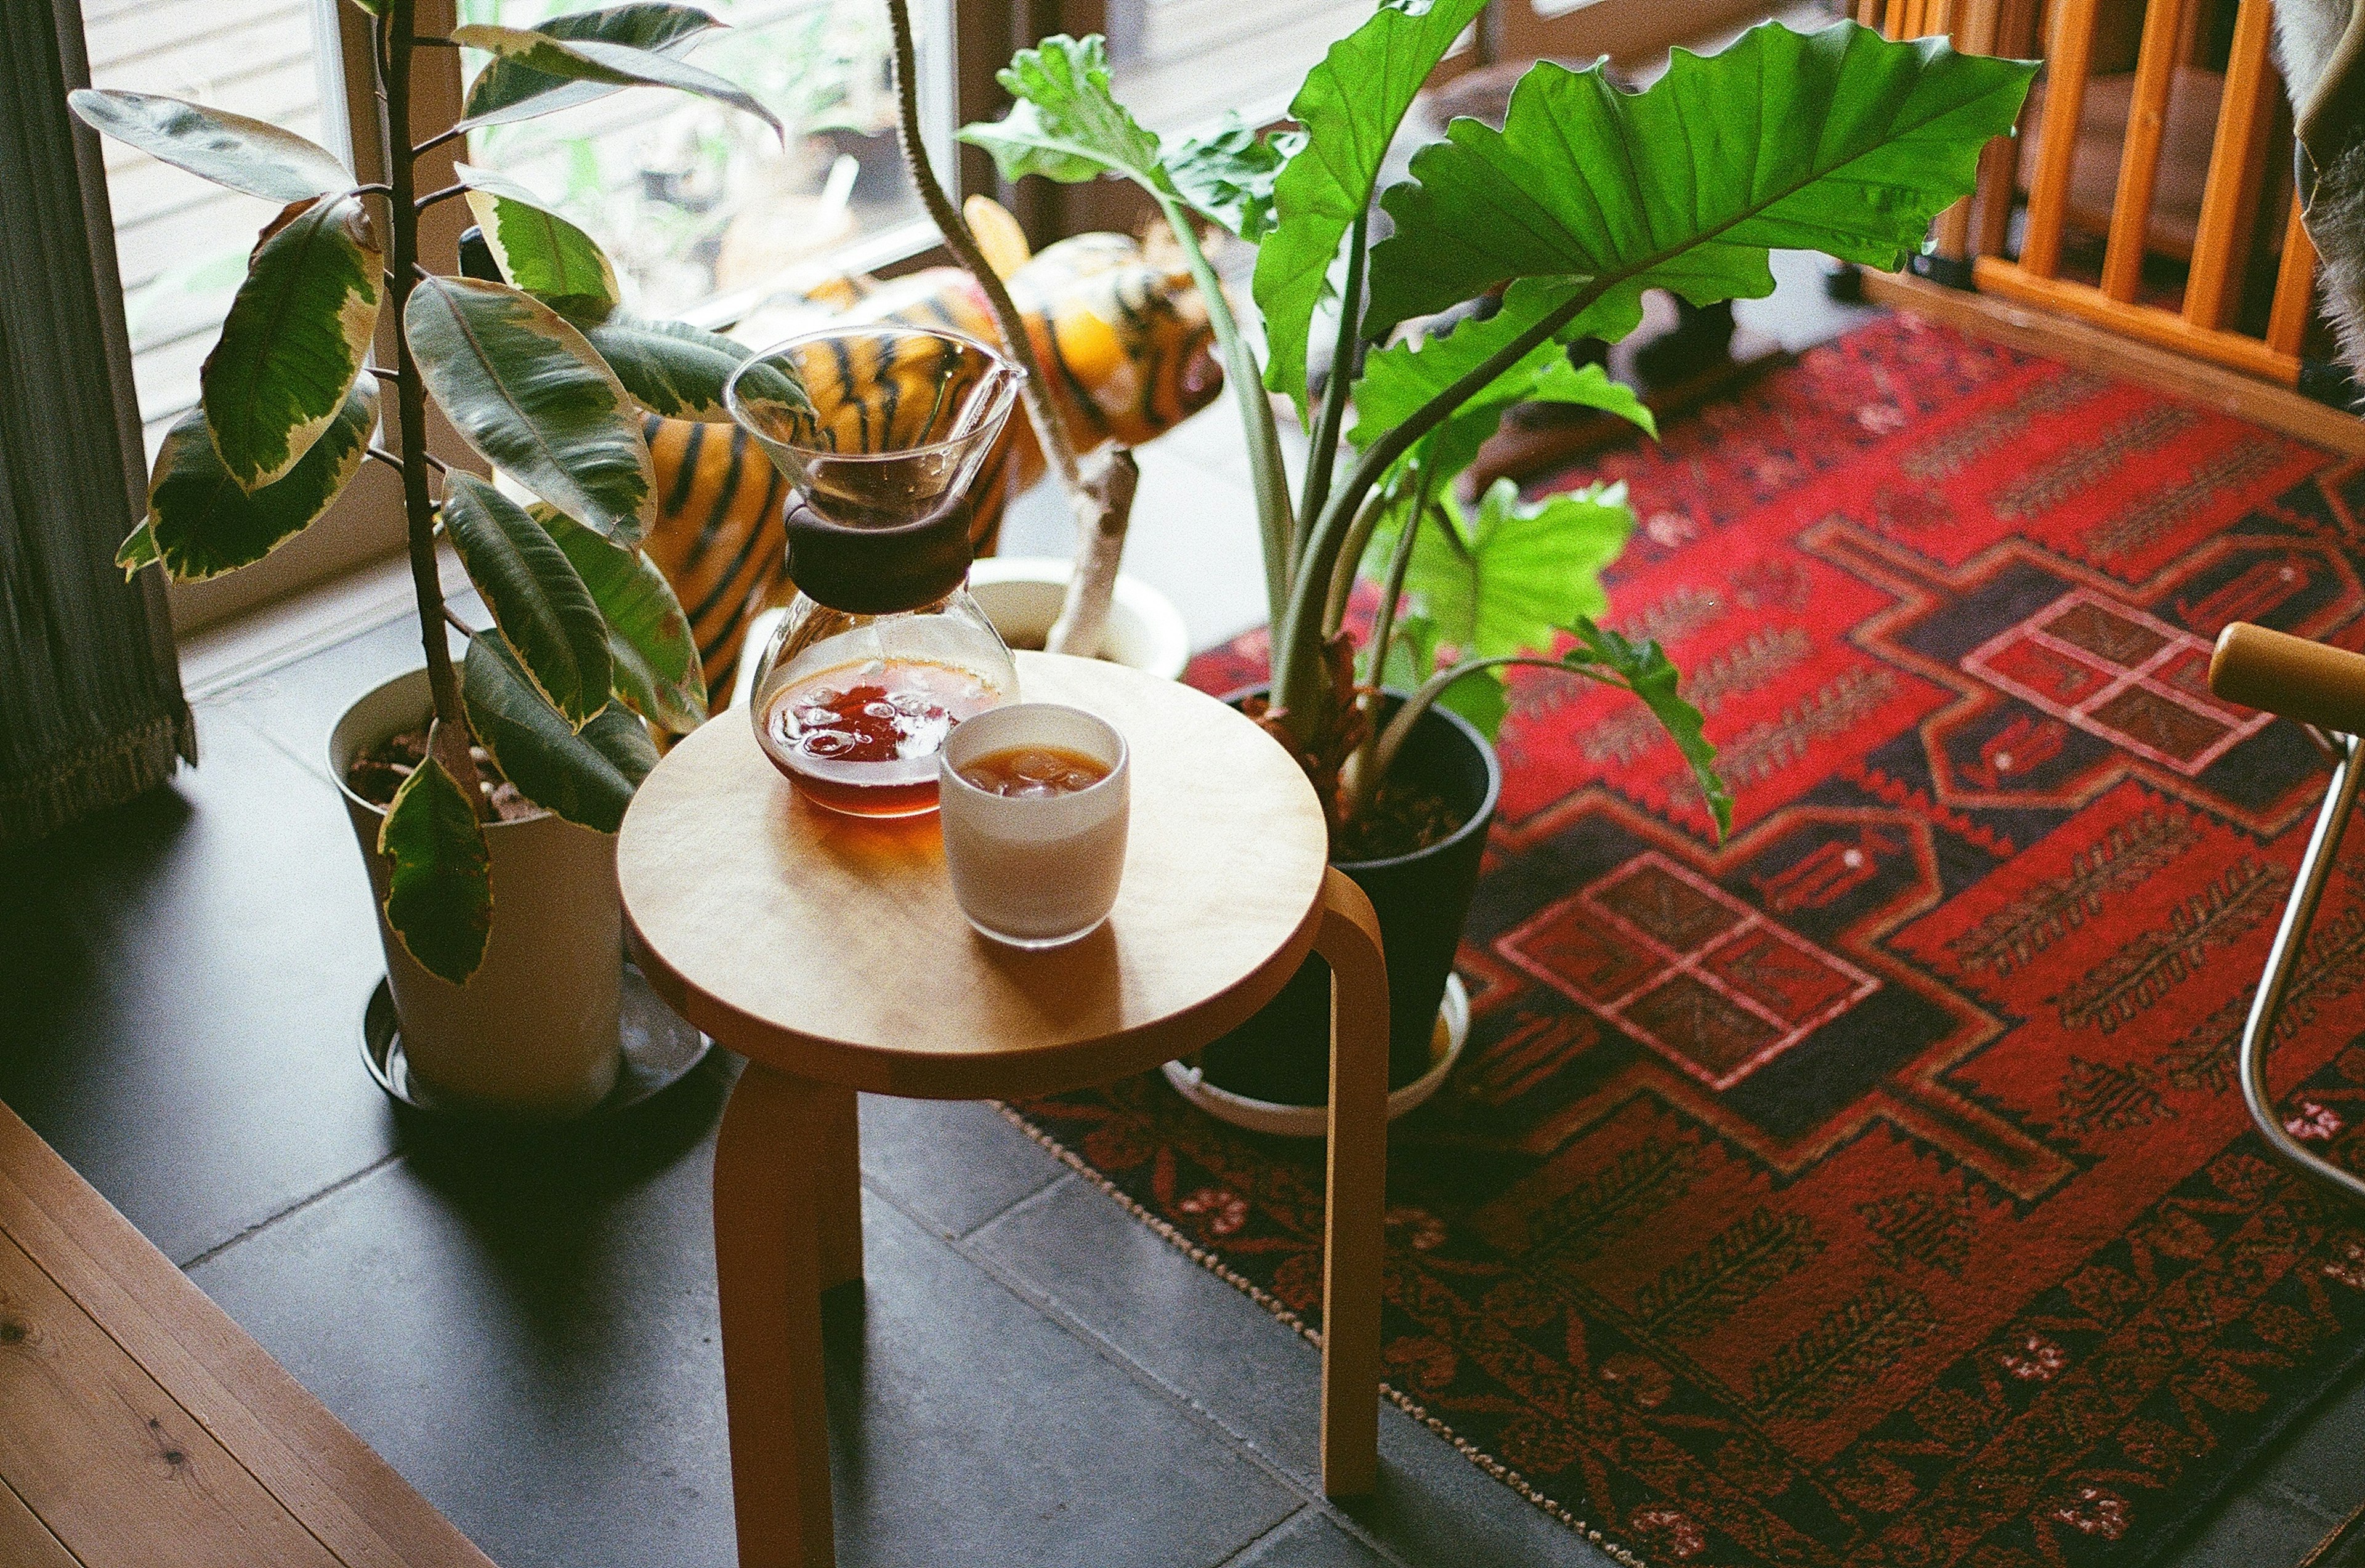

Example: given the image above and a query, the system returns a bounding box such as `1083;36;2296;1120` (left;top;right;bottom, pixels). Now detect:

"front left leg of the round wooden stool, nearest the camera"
714;1062;842;1568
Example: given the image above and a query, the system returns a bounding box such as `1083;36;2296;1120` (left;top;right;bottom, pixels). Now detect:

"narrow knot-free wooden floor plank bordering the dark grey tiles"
0;1104;492;1568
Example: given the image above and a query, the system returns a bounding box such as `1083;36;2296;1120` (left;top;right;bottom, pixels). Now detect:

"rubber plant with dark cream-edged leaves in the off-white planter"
73;0;792;984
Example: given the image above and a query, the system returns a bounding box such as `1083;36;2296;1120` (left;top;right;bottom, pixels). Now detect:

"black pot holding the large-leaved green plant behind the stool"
1199;686;1502;1104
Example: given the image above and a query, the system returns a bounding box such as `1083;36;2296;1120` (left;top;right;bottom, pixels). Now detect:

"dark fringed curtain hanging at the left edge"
0;0;196;844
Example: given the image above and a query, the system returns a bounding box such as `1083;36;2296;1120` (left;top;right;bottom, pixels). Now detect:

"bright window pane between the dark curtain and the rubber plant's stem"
83;0;346;456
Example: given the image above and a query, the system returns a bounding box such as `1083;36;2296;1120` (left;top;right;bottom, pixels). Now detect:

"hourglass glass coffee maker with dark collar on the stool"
724;324;1027;816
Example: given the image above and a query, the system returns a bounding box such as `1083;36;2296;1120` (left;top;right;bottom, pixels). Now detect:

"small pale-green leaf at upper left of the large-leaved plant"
960;33;1175;194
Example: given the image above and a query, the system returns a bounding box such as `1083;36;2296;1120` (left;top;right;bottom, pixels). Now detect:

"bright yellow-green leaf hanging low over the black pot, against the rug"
1374;480;1634;658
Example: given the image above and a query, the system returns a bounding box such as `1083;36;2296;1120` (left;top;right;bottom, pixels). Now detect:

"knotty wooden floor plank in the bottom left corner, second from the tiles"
0;1237;341;1568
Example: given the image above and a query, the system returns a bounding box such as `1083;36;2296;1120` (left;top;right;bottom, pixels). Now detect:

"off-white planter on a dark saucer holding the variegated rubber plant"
329;669;625;1117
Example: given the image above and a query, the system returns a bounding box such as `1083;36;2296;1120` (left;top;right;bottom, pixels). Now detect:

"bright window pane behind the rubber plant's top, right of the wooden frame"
461;0;953;321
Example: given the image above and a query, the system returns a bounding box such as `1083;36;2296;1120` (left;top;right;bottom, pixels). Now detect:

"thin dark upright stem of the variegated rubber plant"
378;0;485;816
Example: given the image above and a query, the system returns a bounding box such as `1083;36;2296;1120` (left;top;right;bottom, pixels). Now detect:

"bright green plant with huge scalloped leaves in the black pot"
963;12;2034;833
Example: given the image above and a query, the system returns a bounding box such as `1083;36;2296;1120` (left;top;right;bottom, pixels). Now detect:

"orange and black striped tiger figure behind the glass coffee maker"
643;196;1223;690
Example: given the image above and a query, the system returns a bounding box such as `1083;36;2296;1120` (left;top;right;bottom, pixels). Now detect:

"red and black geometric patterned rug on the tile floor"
1017;317;2365;1568
